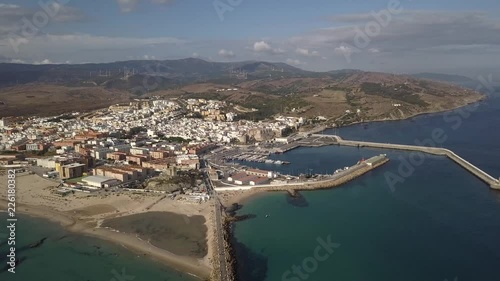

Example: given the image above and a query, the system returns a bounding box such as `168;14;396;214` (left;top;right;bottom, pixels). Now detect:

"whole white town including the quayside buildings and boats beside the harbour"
0;98;312;198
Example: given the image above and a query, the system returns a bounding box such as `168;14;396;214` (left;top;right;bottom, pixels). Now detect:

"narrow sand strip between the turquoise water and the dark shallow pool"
0;199;212;280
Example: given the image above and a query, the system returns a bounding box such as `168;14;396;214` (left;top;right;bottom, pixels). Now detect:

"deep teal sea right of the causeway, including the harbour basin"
233;93;500;281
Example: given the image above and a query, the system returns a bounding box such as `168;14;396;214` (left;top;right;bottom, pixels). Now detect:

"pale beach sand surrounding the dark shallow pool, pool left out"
0;173;215;280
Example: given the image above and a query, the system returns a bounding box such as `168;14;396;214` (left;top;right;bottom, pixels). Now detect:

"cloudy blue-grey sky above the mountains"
0;0;500;76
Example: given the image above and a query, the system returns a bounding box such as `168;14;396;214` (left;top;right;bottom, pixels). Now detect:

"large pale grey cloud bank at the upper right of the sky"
290;10;500;53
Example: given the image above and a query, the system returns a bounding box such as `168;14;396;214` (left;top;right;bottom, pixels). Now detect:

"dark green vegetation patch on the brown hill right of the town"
361;82;429;107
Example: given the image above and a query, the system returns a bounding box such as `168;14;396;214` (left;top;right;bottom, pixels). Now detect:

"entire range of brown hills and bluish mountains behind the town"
0;59;483;123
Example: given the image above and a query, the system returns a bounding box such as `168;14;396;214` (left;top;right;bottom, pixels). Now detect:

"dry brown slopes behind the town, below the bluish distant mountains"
0;69;482;121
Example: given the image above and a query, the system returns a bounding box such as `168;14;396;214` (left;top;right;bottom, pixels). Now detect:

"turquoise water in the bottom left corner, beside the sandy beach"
0;213;198;281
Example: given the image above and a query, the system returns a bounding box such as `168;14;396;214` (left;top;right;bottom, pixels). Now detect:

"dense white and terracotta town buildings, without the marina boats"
0;99;304;190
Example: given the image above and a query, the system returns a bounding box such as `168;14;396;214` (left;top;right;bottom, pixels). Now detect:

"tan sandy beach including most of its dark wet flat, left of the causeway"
0;173;214;279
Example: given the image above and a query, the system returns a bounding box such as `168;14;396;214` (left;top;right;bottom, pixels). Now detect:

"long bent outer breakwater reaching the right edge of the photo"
313;134;500;190
